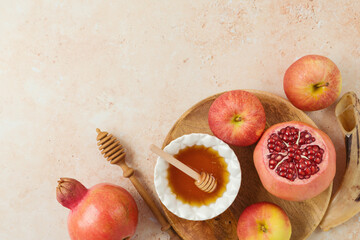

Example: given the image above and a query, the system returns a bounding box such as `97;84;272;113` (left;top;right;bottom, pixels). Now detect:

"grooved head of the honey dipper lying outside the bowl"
96;128;126;164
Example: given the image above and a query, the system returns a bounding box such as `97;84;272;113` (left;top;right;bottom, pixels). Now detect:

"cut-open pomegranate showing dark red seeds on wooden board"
254;121;336;201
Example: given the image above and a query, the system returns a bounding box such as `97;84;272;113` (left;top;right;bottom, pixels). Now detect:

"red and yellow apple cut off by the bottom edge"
237;202;291;240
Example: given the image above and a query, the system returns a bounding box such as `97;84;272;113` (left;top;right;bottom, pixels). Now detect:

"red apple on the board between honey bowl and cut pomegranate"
208;90;266;146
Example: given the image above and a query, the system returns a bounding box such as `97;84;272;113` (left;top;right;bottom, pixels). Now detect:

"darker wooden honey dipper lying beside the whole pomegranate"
96;128;180;240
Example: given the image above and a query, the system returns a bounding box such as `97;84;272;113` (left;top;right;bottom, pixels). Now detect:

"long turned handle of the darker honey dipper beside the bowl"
117;161;180;240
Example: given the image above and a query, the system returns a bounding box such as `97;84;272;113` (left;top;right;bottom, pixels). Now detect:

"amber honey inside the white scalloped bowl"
167;145;229;206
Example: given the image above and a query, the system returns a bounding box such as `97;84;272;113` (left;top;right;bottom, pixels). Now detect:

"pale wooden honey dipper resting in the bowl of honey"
150;144;217;193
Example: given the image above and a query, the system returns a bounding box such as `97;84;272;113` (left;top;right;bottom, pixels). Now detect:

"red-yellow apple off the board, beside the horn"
284;55;341;111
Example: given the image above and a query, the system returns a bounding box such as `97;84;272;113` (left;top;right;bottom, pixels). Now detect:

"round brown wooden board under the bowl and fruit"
163;90;332;240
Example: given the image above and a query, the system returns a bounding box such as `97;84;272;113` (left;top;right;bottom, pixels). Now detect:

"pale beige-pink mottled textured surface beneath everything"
0;0;360;240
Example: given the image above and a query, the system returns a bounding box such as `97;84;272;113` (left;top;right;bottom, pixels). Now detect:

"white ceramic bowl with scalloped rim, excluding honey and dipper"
154;133;241;221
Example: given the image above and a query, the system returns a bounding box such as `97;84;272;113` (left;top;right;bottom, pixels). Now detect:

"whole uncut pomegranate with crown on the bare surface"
56;178;138;240
